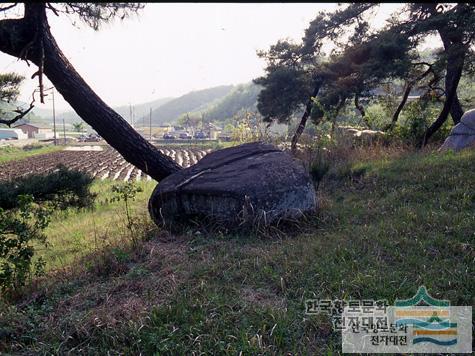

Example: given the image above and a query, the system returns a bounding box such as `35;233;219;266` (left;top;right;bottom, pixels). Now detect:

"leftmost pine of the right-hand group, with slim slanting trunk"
255;4;416;151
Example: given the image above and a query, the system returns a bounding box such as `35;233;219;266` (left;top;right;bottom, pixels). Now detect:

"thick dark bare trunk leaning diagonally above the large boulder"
0;3;181;180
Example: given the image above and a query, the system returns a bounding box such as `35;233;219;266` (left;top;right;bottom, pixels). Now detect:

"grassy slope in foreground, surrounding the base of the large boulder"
0;150;475;355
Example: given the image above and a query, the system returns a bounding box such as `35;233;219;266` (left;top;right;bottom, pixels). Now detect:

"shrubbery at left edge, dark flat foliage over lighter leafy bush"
0;166;96;296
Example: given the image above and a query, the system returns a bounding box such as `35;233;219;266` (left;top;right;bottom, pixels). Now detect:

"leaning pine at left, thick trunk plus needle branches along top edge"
0;3;180;180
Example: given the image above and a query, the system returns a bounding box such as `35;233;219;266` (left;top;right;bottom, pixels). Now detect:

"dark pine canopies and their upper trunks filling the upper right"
255;4;475;149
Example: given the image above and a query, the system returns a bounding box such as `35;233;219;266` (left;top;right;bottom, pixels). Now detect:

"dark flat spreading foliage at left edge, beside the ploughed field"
0;165;96;210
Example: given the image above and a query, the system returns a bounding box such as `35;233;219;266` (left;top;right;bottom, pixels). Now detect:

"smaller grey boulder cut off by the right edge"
439;109;475;151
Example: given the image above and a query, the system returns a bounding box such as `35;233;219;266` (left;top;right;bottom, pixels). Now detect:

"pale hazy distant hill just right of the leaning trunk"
142;85;234;126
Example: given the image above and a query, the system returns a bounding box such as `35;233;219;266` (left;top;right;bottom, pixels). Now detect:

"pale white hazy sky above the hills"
0;3;410;111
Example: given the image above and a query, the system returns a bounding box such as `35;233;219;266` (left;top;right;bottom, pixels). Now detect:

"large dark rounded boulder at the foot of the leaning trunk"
149;142;316;224
